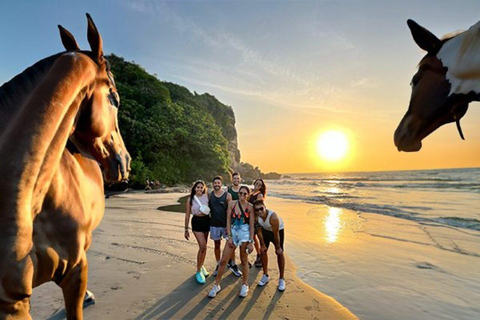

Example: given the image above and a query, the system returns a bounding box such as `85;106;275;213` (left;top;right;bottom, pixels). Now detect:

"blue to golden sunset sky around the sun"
0;0;480;173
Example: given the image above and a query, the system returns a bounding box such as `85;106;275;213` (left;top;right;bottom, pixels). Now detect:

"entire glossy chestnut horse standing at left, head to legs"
0;14;130;319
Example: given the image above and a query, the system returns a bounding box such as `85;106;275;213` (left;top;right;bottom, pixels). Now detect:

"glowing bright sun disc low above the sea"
317;130;349;161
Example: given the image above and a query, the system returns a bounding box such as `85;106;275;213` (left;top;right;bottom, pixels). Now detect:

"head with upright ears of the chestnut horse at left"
63;14;131;182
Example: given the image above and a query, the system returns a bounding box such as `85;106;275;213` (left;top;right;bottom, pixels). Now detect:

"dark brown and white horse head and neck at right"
394;20;480;151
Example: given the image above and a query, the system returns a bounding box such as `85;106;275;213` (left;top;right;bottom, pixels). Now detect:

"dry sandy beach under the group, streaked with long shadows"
31;193;356;320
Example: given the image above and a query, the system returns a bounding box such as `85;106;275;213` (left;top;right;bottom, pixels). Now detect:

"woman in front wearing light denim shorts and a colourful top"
208;186;255;298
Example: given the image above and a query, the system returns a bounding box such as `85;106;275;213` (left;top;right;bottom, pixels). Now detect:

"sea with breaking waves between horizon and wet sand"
266;168;480;231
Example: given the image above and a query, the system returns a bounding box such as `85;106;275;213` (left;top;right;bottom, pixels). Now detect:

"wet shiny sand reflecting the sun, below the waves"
267;197;480;320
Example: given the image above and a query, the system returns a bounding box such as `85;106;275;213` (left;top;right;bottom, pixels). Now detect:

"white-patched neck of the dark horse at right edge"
437;22;480;97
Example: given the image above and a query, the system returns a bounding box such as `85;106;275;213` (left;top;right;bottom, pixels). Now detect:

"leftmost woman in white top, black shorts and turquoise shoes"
185;181;210;284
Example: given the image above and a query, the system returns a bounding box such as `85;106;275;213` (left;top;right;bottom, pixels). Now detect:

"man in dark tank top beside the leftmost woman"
208;176;232;276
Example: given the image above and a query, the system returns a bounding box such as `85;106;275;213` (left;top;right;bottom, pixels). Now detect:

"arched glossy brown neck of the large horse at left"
0;53;95;234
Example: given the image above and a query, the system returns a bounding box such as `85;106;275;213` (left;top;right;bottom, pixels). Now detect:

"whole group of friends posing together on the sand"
185;172;285;298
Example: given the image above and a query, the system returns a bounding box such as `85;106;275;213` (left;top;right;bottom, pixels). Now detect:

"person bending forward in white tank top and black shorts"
253;199;285;291
